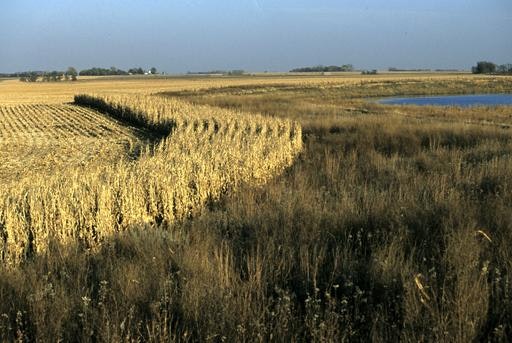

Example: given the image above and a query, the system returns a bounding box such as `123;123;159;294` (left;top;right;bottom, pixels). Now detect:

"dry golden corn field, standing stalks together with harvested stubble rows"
0;95;302;265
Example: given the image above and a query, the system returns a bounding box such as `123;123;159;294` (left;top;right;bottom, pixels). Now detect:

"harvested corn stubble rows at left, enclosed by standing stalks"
0;104;147;184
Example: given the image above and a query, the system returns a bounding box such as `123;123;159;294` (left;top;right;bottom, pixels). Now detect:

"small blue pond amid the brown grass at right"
378;94;512;107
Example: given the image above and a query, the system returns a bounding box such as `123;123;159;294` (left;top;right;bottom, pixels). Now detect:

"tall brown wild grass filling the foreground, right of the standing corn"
0;76;512;342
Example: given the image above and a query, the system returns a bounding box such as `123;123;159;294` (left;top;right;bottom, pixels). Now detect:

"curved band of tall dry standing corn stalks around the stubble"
0;96;302;265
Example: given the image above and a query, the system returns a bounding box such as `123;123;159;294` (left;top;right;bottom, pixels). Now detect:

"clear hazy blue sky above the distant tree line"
0;0;512;73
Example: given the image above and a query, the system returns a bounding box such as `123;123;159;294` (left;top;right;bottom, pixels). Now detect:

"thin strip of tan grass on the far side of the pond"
167;75;512;100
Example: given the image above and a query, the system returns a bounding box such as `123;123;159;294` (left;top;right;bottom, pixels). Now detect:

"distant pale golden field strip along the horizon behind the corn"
0;73;502;104
